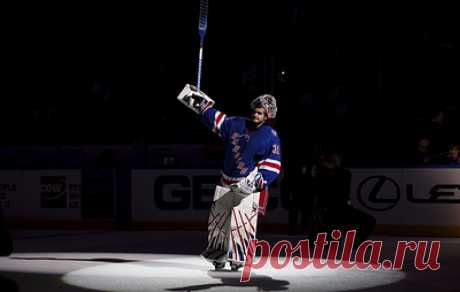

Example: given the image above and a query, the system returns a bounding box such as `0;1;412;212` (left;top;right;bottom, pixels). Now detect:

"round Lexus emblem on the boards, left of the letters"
358;176;401;211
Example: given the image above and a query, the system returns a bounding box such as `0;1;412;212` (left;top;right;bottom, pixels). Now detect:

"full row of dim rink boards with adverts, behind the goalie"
0;168;460;234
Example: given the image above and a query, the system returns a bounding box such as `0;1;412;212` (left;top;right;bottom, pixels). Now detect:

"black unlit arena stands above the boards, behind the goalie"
0;0;459;165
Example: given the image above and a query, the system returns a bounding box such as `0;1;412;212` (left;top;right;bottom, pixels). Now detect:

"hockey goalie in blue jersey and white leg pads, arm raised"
178;85;281;270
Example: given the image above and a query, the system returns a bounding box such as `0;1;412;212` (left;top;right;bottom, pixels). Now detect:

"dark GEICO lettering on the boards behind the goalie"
153;175;288;210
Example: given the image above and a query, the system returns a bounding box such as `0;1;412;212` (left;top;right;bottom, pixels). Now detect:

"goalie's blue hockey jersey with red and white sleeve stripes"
202;108;281;186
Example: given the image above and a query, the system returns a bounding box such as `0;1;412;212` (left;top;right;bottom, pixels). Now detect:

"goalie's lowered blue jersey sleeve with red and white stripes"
257;130;281;187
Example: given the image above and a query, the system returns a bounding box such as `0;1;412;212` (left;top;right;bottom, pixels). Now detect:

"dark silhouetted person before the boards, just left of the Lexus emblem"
310;149;376;246
